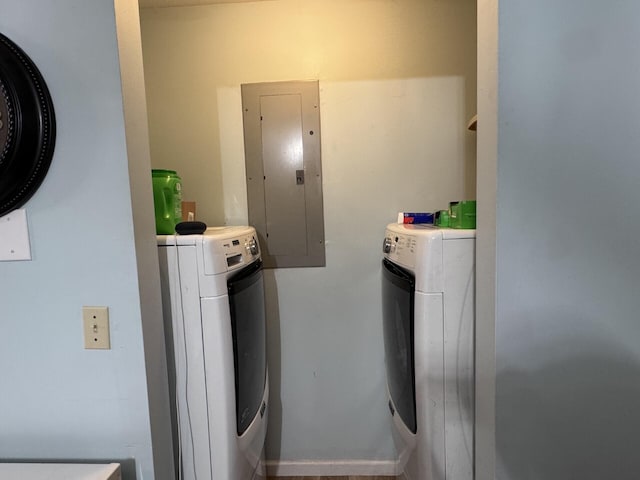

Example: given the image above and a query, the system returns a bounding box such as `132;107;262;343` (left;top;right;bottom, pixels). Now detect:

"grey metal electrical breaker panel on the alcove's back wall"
242;81;325;268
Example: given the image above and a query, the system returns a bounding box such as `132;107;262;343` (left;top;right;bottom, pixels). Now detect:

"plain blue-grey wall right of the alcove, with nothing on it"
478;0;640;480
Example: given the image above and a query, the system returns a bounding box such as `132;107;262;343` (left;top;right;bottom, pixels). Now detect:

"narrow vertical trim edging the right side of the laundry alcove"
475;0;498;480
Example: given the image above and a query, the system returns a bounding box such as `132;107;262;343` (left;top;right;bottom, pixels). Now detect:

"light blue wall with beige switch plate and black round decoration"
0;0;171;479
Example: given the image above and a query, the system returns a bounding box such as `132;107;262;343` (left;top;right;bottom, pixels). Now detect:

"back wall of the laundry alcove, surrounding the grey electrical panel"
141;0;475;475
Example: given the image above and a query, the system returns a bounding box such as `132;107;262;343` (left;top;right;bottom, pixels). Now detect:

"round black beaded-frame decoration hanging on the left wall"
0;33;56;216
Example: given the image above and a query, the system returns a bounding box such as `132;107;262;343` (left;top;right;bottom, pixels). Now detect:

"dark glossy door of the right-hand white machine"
382;259;416;433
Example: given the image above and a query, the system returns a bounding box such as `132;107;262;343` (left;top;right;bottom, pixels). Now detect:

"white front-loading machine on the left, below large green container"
158;227;269;480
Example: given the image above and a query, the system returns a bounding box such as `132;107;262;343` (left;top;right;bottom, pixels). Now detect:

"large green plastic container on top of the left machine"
151;170;182;235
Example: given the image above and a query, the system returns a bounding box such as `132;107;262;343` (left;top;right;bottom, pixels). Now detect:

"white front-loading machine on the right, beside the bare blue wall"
382;224;475;480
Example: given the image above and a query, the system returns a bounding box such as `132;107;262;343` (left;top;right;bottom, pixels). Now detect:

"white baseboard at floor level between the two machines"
264;460;398;477
